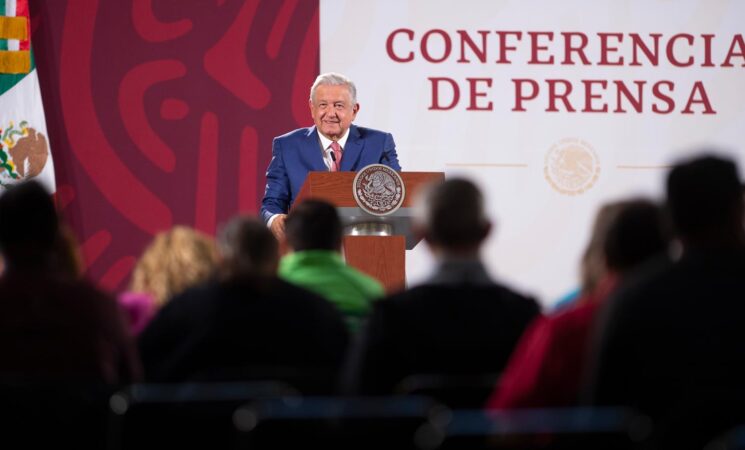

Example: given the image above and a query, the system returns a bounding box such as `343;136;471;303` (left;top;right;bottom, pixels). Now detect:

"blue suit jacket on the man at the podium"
261;125;401;222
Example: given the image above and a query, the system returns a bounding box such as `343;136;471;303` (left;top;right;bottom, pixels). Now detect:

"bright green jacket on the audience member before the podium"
279;250;385;332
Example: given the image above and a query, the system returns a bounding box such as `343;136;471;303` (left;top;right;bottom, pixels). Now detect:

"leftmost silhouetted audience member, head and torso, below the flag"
0;181;140;384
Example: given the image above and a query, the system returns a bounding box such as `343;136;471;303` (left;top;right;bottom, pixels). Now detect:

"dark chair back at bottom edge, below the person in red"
419;408;652;450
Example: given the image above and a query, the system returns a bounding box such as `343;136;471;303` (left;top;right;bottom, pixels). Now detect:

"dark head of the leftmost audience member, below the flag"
0;181;60;268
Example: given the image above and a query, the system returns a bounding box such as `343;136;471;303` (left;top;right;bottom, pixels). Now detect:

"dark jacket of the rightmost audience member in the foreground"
588;249;745;448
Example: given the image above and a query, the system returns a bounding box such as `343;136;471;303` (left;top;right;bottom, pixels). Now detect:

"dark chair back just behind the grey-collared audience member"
394;373;499;408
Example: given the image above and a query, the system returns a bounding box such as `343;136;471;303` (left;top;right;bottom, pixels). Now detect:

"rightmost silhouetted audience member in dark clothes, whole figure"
589;156;745;448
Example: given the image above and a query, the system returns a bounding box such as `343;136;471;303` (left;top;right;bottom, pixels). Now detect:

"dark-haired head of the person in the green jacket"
285;200;342;252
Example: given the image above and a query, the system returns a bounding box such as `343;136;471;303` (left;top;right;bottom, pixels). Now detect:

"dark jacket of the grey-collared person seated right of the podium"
345;283;539;394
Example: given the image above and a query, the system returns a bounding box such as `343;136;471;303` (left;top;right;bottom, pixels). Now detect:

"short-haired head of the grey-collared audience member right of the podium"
414;178;491;257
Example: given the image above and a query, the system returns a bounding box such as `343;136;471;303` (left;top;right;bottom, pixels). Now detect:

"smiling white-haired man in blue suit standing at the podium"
261;72;401;238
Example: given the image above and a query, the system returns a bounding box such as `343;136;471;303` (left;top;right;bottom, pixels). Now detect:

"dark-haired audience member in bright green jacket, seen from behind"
279;200;384;332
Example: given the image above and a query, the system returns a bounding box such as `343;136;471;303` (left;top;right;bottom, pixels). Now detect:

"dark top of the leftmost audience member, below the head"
0;272;140;384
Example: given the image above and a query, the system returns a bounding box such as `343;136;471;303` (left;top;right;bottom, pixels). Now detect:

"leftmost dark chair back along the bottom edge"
107;382;297;450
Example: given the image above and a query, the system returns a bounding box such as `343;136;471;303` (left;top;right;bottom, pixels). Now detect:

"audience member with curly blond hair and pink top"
118;225;217;335
